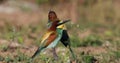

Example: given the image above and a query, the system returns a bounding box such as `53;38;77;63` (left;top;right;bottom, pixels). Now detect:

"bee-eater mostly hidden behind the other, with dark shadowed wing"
48;11;76;60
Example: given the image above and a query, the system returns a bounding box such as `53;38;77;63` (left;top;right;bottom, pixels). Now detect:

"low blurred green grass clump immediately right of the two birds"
71;35;103;47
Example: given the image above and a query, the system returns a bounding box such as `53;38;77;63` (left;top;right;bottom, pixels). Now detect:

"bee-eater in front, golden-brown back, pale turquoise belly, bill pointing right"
31;20;70;59
